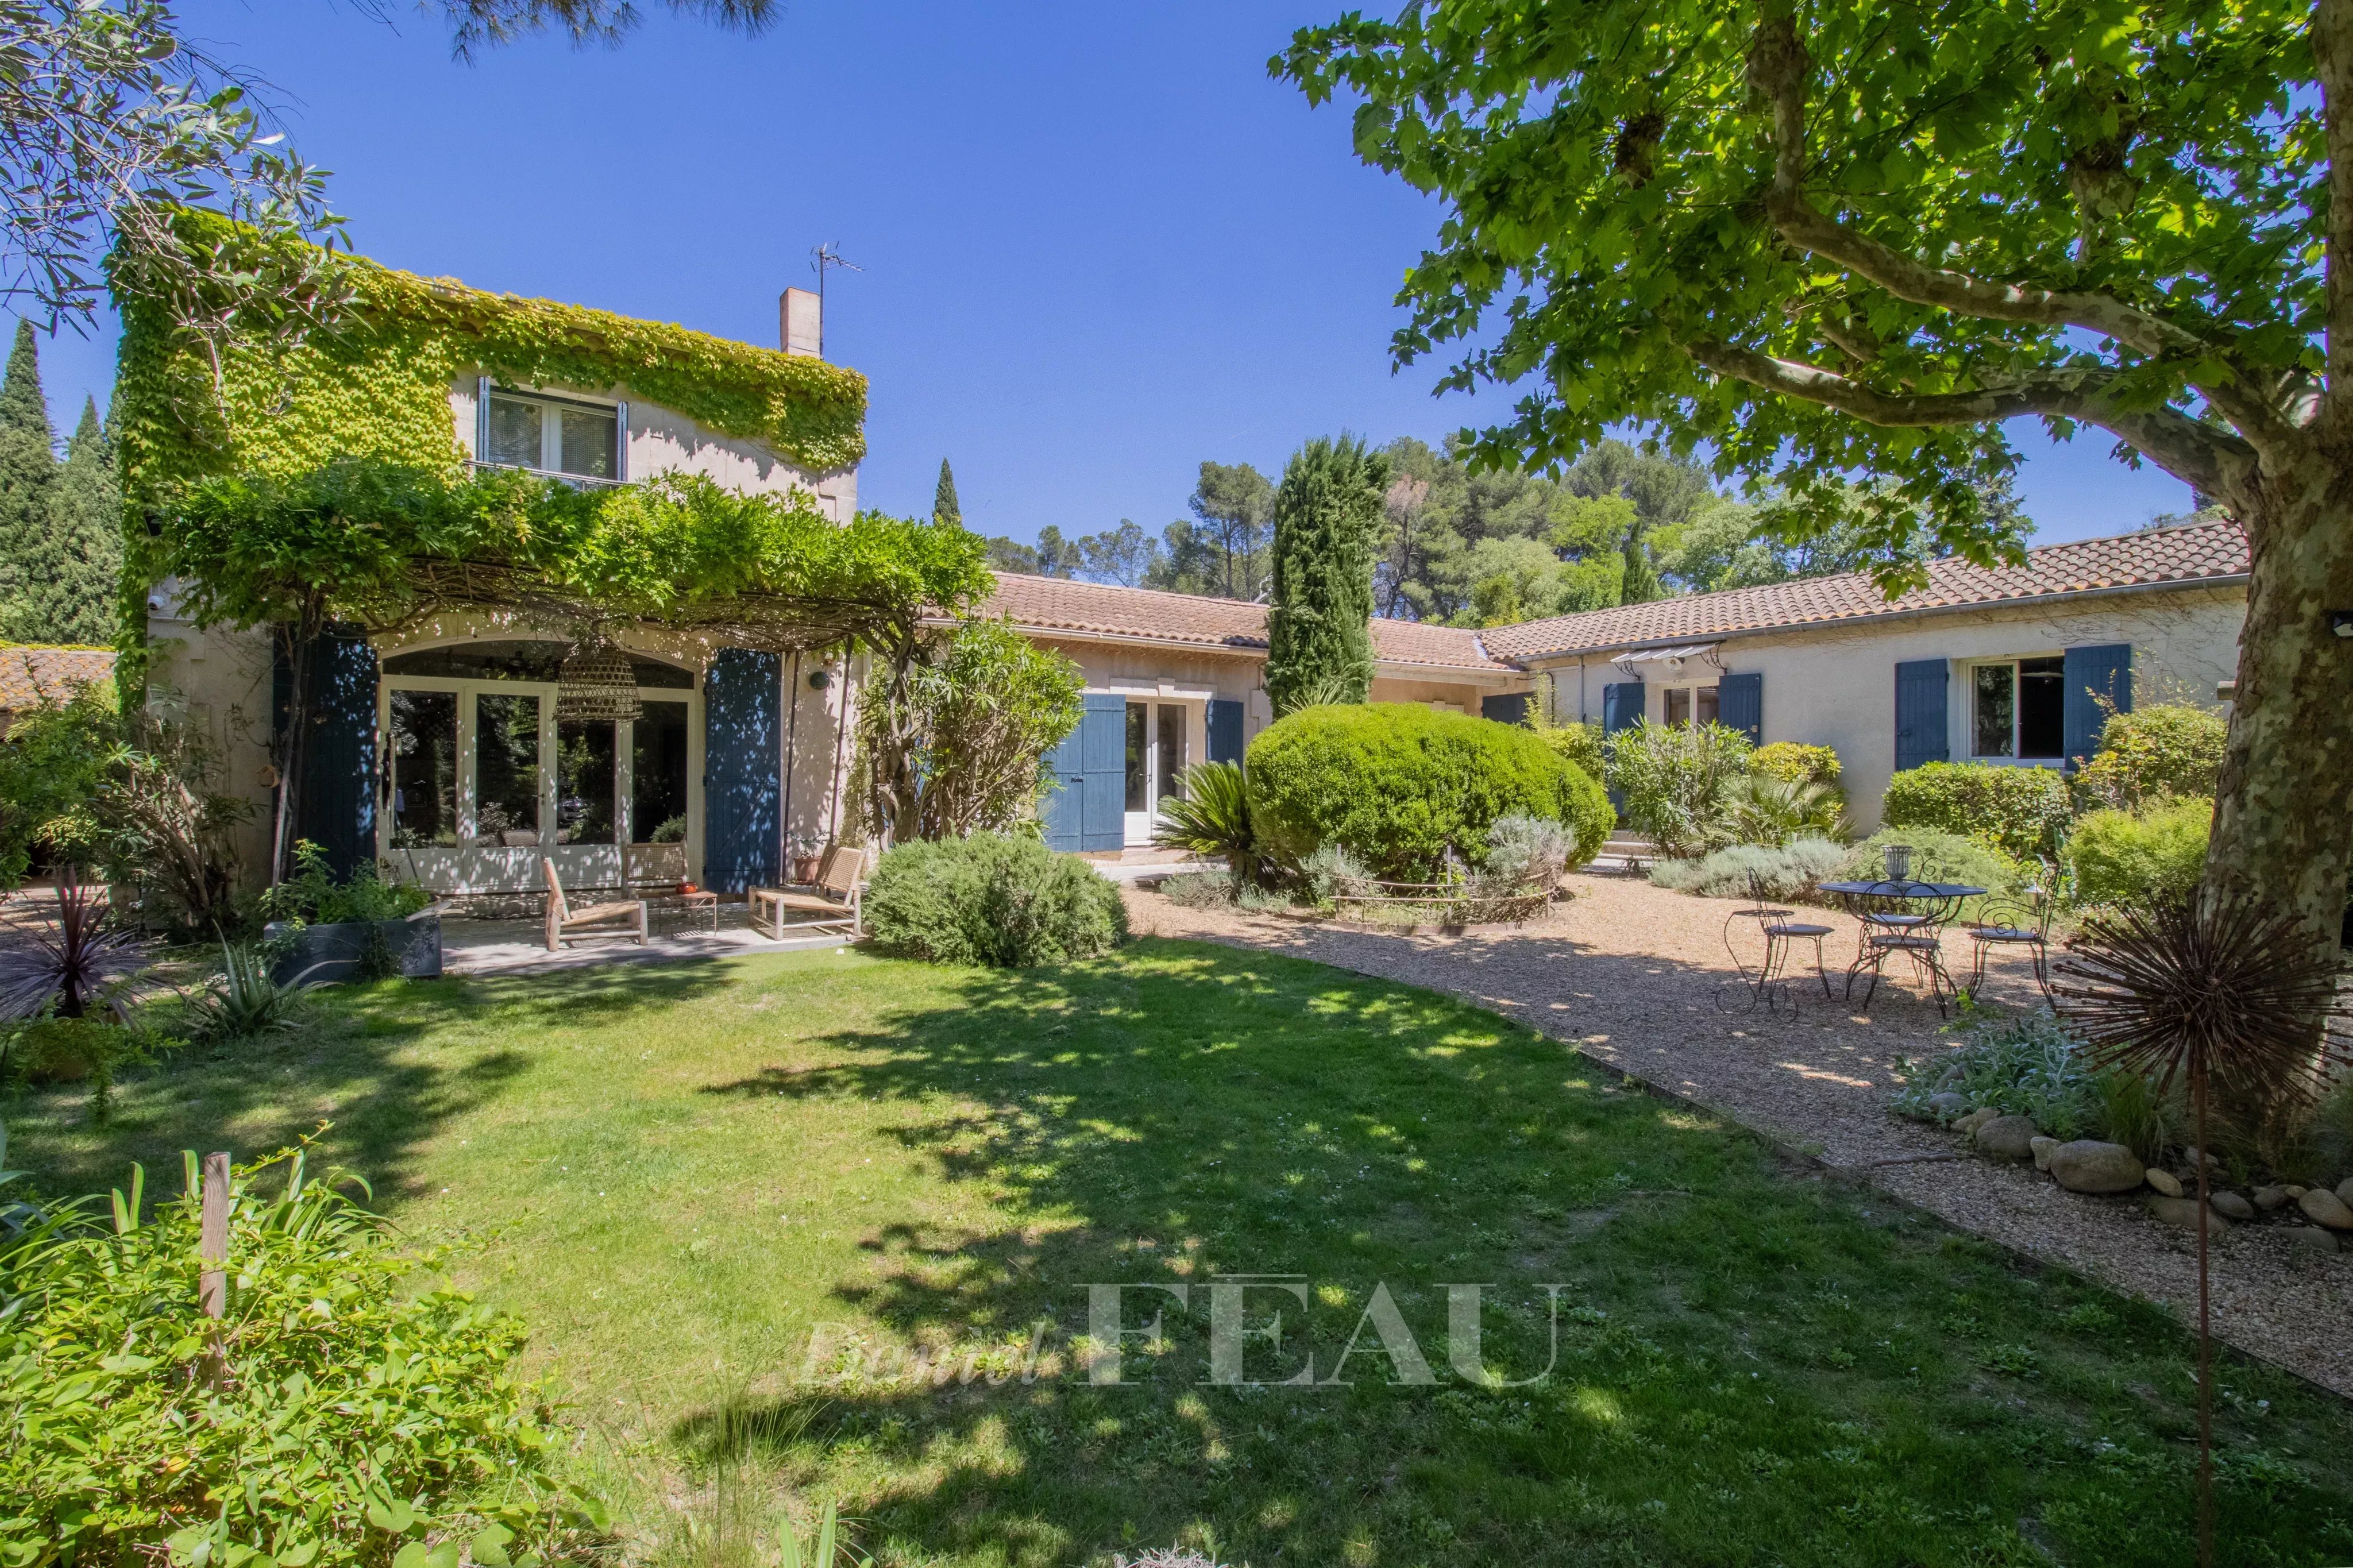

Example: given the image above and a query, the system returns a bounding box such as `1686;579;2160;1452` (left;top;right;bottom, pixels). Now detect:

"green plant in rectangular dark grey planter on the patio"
261;839;440;985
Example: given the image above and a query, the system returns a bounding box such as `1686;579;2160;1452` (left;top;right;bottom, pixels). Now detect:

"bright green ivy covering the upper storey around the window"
113;243;866;505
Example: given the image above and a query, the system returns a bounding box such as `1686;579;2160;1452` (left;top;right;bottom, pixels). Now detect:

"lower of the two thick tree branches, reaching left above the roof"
1683;338;2256;496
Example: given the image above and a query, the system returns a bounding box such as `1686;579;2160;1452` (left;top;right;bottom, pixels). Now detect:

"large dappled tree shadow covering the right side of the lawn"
673;940;2353;1566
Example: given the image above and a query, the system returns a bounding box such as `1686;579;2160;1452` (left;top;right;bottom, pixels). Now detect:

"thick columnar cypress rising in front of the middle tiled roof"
1266;435;1388;712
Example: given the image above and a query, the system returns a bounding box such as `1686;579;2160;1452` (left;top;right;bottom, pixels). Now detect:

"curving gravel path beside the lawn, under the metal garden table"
1127;877;2353;1396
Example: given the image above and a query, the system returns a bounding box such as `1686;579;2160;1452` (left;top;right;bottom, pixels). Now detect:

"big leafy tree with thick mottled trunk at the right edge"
1271;0;2353;959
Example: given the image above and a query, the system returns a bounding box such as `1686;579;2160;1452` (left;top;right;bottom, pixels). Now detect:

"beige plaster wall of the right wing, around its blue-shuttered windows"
1544;585;2247;832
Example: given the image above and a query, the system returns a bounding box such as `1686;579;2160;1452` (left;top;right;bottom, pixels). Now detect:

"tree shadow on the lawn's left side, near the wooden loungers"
7;964;734;1201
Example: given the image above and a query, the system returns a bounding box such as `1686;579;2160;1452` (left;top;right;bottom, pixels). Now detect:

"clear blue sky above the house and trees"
43;0;2188;552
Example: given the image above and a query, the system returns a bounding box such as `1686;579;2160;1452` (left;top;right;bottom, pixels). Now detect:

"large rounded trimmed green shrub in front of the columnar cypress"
1247;703;1614;877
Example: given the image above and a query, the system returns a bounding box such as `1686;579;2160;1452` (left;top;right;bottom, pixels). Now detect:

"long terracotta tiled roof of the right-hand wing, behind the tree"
1480;520;2247;661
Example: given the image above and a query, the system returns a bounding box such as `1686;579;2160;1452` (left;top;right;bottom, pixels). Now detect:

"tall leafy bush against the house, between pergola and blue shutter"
859;621;1087;839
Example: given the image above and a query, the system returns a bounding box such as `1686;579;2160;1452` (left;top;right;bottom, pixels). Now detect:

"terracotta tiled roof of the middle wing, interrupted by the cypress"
979;571;1511;673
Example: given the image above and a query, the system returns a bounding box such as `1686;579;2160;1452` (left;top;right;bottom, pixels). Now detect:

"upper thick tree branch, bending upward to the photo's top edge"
1748;0;2296;456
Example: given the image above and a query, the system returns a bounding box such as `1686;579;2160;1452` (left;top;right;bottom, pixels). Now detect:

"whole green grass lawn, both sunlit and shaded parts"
9;943;2353;1568
